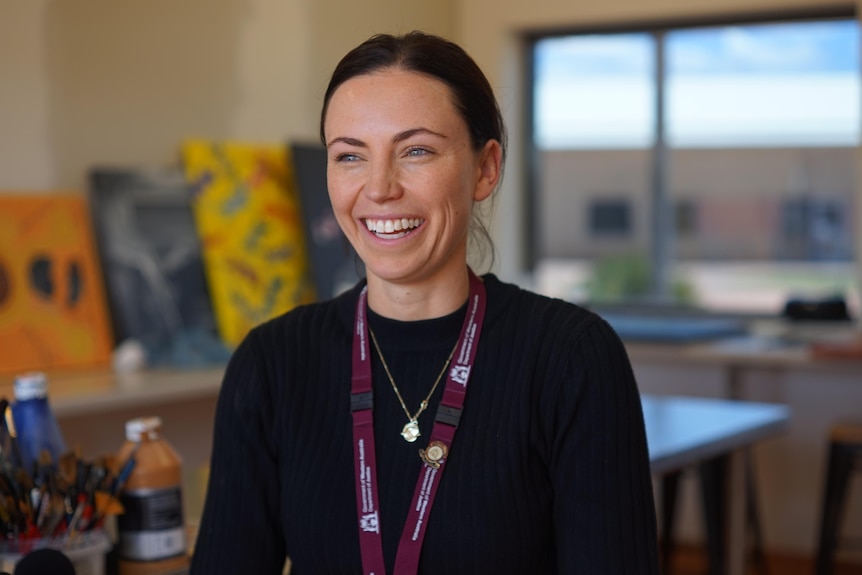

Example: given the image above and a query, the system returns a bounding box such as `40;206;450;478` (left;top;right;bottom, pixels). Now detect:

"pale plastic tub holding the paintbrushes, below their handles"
0;530;111;575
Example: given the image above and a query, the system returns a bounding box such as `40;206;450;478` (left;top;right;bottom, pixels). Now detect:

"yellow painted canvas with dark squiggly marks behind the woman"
182;140;315;346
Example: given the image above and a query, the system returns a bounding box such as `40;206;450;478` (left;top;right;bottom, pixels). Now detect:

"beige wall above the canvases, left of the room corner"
0;0;454;194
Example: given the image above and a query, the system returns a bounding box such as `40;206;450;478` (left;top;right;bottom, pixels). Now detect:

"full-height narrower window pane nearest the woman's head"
534;33;656;300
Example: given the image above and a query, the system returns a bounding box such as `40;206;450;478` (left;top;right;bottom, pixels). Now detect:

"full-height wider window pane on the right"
665;20;860;312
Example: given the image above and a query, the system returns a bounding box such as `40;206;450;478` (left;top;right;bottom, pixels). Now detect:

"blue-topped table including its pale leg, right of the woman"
642;394;790;575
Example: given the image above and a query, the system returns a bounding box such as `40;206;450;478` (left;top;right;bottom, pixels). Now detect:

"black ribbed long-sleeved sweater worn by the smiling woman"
191;275;658;575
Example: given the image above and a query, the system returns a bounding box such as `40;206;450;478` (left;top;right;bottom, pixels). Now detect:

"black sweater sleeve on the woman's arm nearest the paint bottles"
191;331;285;575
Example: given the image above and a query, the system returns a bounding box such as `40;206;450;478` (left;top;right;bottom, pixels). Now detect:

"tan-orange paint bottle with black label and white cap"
117;417;189;575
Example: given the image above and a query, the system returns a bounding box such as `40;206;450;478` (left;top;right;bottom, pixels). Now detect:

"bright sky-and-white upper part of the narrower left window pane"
534;33;655;149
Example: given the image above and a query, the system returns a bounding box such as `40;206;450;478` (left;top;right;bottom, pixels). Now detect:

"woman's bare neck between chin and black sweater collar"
368;266;470;321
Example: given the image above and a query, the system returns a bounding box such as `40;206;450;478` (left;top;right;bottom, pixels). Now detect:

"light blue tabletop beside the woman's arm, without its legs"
642;395;790;473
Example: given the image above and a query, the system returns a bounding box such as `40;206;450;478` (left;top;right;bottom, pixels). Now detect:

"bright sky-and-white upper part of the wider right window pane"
666;20;860;147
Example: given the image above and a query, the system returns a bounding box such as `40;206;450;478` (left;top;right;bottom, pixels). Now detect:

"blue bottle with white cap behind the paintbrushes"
11;372;66;473
